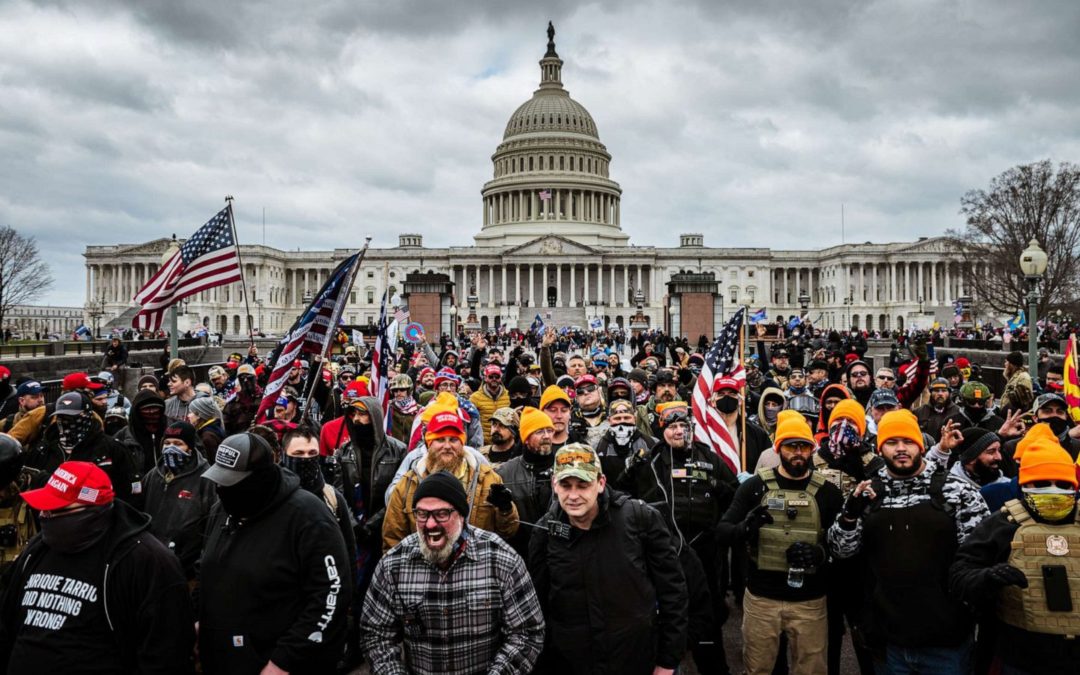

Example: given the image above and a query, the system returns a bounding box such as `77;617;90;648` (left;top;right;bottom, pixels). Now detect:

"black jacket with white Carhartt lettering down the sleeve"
199;470;352;675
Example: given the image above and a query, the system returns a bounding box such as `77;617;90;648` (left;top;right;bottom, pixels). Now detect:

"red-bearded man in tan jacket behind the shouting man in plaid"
382;410;517;552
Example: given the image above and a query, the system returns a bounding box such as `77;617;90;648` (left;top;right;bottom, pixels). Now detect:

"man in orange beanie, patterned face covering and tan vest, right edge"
949;424;1080;675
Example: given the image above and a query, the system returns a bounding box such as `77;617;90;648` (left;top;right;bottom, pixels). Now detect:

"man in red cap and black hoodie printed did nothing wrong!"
0;461;194;675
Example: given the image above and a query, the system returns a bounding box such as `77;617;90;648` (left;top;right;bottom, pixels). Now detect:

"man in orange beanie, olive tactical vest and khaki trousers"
717;410;842;675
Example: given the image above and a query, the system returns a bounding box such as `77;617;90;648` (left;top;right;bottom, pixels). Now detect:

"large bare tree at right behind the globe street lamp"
947;160;1080;316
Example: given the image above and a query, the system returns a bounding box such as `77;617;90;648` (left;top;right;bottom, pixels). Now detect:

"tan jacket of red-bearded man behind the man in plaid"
382;453;518;553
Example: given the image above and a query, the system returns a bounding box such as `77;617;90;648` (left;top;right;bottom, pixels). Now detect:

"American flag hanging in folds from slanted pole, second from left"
255;247;366;420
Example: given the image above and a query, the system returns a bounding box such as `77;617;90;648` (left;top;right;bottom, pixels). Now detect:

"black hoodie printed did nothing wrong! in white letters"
0;501;195;675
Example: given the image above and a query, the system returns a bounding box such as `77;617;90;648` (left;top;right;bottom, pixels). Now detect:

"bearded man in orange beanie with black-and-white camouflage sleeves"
828;409;989;674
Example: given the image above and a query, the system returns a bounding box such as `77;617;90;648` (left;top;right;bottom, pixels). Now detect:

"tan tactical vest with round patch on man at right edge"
998;499;1080;637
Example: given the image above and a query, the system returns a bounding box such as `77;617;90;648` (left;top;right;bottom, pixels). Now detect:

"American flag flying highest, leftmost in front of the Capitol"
132;205;242;330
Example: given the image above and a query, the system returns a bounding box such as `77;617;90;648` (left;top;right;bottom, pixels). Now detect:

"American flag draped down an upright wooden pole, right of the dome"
691;307;746;473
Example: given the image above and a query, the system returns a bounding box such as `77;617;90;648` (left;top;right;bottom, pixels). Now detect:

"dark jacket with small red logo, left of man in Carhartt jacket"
143;448;217;579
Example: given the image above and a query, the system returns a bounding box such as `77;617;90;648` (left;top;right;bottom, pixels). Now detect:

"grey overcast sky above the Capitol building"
0;0;1080;305
